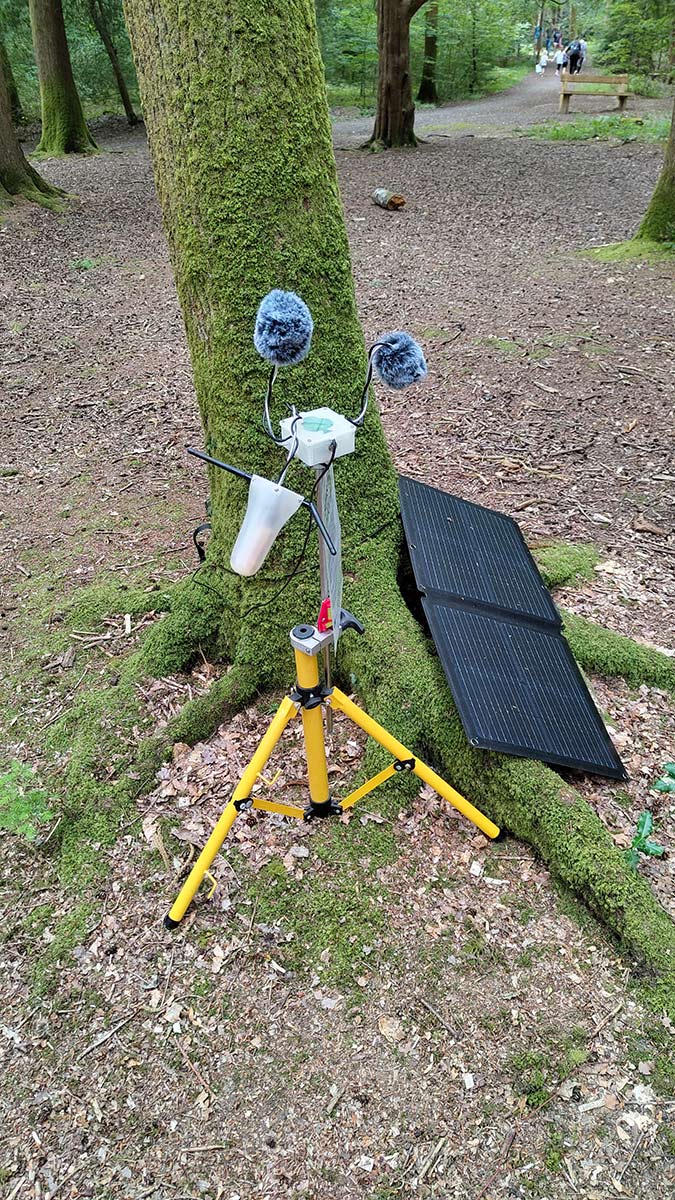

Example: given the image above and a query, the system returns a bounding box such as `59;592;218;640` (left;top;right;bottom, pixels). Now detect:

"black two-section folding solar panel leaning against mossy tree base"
399;479;627;779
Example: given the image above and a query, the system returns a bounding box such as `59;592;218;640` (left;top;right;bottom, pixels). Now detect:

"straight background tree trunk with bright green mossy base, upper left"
29;0;96;157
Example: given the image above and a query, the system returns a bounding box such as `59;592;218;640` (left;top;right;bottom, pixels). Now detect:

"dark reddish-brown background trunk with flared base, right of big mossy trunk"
370;0;425;146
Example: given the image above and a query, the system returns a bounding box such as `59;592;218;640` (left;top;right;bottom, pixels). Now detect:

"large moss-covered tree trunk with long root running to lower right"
125;0;675;1016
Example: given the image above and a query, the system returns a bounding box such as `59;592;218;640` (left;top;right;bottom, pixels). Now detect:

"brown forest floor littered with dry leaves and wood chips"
0;80;675;1200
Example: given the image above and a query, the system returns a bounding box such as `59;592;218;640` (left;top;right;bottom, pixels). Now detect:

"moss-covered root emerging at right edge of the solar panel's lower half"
562;610;675;692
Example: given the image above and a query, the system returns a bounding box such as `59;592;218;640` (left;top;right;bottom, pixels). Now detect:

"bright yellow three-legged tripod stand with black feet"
165;612;500;929
